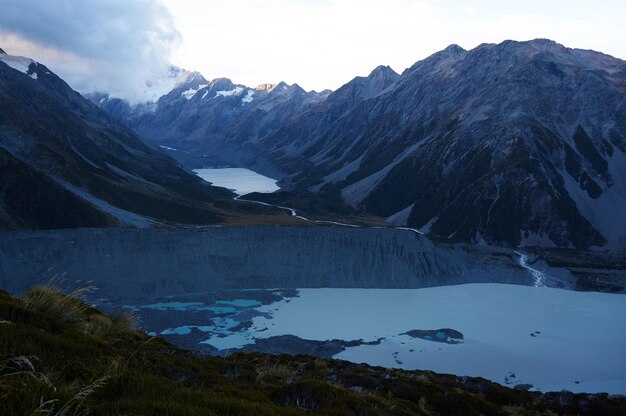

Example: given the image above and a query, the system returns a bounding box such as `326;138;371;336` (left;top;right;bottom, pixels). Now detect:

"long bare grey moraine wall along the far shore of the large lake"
0;226;532;300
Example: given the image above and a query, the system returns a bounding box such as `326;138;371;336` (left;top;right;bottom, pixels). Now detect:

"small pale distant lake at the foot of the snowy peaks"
194;168;280;196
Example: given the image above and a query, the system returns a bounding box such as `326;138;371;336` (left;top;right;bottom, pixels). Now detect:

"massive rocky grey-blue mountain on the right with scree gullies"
262;40;626;253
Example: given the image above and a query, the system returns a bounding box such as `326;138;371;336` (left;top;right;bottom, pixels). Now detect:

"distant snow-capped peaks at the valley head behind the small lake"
87;74;329;177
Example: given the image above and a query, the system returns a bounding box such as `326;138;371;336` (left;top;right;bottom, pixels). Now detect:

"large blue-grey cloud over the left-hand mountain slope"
0;0;181;101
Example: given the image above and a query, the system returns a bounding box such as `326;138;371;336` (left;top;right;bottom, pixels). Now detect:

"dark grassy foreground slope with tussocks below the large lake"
0;287;626;416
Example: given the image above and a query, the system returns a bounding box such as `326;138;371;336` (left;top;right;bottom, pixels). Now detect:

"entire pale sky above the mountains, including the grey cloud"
0;0;626;99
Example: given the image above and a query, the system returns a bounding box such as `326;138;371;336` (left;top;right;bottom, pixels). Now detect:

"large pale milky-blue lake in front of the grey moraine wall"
114;284;626;394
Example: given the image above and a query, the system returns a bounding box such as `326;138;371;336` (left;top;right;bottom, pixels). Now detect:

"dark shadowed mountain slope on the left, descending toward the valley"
0;52;249;228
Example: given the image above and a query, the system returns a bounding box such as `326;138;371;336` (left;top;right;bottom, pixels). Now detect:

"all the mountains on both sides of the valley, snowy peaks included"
0;39;626;255
